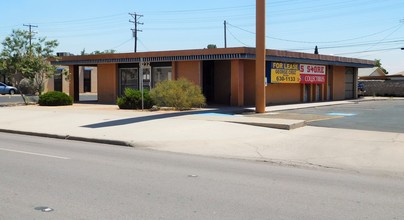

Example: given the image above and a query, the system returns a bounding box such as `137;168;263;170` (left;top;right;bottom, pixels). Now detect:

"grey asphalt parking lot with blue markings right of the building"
255;99;404;133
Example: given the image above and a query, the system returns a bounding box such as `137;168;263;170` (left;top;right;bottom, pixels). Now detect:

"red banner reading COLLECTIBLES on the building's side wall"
300;64;326;84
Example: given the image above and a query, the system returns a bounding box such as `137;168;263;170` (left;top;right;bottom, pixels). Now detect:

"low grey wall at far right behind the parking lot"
359;80;404;97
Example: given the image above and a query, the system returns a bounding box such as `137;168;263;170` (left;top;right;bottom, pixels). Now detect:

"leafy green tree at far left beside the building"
0;30;59;101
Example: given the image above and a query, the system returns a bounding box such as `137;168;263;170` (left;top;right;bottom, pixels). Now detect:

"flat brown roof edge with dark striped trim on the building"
52;47;374;68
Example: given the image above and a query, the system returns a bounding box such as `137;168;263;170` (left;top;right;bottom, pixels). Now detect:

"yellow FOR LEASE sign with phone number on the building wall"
271;62;300;83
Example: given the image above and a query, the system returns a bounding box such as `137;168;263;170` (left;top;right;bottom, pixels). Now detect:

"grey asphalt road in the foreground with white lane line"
0;133;404;220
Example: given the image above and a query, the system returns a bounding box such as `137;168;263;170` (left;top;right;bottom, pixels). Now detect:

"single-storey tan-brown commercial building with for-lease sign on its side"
53;47;374;106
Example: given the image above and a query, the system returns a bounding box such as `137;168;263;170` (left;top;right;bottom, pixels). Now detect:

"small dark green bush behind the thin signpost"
116;88;154;109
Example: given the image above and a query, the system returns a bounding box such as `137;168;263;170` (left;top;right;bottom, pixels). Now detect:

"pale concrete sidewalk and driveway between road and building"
0;100;404;177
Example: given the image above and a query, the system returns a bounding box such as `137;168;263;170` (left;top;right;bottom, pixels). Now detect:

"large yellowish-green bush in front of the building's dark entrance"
150;79;206;110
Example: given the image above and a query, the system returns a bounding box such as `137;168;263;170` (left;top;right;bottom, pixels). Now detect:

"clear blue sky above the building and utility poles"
0;0;404;74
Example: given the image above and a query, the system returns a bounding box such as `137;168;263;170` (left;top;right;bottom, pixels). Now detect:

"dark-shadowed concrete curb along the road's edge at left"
0;129;135;147
